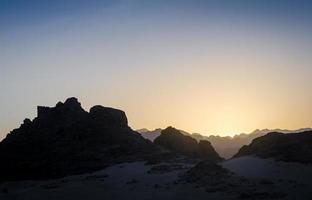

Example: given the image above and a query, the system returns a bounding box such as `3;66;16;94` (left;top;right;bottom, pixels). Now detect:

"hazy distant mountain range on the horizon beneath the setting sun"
136;128;312;158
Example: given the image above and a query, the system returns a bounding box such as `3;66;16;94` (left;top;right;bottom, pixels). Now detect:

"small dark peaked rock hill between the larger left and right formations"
154;127;222;161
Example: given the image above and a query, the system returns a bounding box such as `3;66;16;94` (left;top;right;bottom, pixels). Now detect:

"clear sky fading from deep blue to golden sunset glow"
0;0;312;139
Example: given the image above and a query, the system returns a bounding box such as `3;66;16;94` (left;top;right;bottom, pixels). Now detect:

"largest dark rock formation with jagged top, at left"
0;98;158;180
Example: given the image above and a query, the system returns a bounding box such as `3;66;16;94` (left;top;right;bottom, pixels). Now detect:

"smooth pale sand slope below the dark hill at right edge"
222;156;312;199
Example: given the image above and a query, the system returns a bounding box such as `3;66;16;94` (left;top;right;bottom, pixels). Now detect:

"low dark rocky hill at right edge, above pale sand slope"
235;131;312;163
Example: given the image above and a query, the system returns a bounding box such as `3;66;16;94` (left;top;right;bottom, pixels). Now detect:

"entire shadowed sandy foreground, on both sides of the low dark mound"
0;157;312;200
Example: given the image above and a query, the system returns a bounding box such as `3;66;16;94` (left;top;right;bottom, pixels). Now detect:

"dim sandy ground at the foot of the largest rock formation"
0;162;214;200
